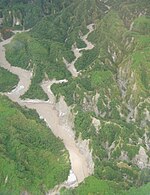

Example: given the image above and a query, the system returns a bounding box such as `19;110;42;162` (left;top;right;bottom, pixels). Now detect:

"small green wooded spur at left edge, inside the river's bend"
0;67;19;92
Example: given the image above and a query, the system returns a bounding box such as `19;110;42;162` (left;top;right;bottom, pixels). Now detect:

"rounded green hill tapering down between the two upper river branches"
6;29;70;100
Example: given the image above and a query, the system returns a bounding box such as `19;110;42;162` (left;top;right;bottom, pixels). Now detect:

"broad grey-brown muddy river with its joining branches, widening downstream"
0;26;94;193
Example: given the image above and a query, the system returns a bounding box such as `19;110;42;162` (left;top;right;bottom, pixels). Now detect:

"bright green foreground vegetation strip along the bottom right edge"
60;176;150;195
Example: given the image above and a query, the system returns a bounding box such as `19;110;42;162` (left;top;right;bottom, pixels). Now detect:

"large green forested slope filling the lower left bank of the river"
0;96;70;194
